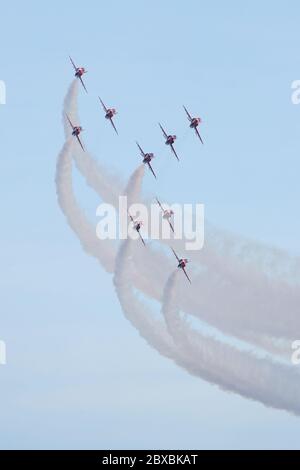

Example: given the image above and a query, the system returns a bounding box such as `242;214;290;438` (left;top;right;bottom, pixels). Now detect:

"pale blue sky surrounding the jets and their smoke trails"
0;0;300;448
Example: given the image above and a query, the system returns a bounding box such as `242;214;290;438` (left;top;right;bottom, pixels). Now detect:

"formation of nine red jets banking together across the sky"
66;57;199;283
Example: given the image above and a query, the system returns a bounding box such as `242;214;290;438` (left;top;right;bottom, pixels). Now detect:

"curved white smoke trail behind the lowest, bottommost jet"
162;271;300;415
